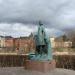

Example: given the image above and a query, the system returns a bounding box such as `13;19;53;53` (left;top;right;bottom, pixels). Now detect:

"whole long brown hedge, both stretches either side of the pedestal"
0;55;75;70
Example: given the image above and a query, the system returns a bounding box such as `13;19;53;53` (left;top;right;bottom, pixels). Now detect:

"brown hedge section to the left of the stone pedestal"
0;55;27;67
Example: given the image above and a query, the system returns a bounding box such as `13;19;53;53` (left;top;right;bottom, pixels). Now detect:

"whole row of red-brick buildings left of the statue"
4;35;35;53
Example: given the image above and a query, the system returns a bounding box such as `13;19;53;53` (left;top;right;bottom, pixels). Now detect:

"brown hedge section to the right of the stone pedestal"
54;55;75;70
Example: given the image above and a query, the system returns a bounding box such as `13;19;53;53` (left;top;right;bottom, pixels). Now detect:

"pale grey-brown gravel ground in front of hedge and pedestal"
0;67;75;75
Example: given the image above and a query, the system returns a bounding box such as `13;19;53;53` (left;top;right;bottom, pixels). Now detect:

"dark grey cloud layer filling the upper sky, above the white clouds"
0;0;75;36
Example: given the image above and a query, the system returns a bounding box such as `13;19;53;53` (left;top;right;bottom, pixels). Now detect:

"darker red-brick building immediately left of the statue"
14;37;35;53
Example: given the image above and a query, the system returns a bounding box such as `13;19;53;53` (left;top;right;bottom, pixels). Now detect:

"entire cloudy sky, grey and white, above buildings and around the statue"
0;0;75;37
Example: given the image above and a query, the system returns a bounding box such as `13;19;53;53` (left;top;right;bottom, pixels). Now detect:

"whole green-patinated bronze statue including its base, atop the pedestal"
29;22;52;61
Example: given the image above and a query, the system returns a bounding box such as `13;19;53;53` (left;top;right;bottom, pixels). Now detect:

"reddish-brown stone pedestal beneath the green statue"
25;60;56;72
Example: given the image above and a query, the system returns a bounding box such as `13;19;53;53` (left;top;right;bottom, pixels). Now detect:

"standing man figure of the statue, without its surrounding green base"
36;22;47;54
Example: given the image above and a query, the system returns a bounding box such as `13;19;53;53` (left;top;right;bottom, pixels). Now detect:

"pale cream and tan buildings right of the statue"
50;36;72;48
